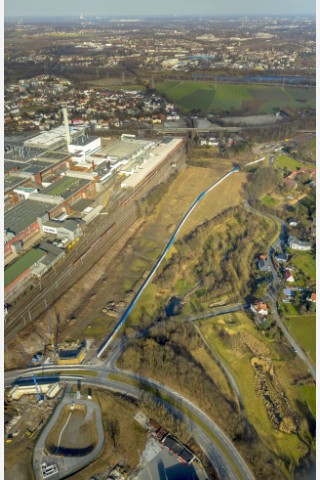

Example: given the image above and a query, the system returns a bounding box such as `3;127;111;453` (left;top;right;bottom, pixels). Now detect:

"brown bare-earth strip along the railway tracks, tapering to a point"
4;220;142;370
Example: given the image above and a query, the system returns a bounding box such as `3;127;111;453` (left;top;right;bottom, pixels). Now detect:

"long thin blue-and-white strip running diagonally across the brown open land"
97;167;239;358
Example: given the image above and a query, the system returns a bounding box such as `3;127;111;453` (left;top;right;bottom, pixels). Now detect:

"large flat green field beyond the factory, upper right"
156;80;315;114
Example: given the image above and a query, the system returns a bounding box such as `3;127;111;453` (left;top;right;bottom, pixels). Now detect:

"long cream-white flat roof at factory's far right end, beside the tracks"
121;138;183;188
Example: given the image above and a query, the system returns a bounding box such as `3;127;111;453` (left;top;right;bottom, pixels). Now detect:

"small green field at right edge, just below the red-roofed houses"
286;315;316;361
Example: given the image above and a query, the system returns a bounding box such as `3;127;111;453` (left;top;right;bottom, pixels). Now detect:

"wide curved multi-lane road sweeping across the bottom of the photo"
4;362;254;480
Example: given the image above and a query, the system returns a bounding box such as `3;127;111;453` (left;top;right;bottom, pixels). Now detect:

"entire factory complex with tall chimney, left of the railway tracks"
4;118;184;303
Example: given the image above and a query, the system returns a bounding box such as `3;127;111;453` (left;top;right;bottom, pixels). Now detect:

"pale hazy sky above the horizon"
4;0;316;17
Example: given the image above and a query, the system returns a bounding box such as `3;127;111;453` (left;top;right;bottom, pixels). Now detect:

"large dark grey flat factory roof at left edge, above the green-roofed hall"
4;200;56;235
